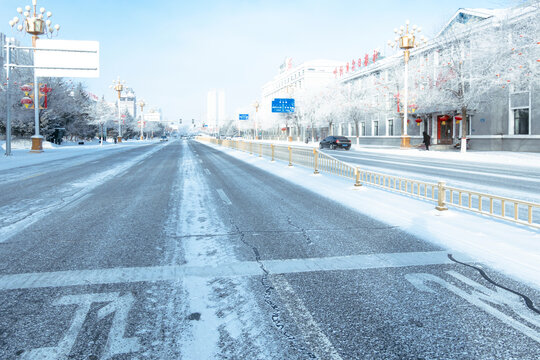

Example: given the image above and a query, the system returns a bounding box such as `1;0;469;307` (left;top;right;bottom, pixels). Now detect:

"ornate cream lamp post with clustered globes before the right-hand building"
388;20;427;148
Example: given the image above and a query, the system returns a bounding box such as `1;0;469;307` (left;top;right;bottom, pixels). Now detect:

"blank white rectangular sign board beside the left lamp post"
34;39;99;77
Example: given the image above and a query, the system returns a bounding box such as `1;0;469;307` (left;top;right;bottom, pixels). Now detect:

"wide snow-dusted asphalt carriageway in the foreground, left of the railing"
0;141;540;359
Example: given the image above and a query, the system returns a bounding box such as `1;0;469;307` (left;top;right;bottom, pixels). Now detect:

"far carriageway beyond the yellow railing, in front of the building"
323;150;540;202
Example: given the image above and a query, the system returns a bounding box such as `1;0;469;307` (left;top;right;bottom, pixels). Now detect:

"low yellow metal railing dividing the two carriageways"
198;137;540;229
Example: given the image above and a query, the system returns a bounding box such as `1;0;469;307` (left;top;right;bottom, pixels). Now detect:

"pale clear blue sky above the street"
0;0;516;120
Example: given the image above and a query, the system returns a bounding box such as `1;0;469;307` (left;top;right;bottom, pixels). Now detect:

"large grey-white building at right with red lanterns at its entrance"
333;6;540;152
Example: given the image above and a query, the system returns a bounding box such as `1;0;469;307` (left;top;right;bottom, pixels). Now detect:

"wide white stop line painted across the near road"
0;251;456;290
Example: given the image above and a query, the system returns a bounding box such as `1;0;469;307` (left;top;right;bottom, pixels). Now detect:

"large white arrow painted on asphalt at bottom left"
21;293;140;360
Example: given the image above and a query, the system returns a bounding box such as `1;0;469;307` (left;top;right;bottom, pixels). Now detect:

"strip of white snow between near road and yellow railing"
198;142;540;289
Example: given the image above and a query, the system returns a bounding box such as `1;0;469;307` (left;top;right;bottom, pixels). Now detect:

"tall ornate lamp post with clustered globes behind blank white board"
9;0;60;153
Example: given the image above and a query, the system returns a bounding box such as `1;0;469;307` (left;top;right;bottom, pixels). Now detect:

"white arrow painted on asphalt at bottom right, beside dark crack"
405;271;540;343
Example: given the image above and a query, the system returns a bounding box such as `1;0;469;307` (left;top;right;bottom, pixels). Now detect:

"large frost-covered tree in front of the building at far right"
416;1;540;151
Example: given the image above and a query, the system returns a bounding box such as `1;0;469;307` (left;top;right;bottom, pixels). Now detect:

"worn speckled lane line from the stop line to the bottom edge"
270;275;341;360
